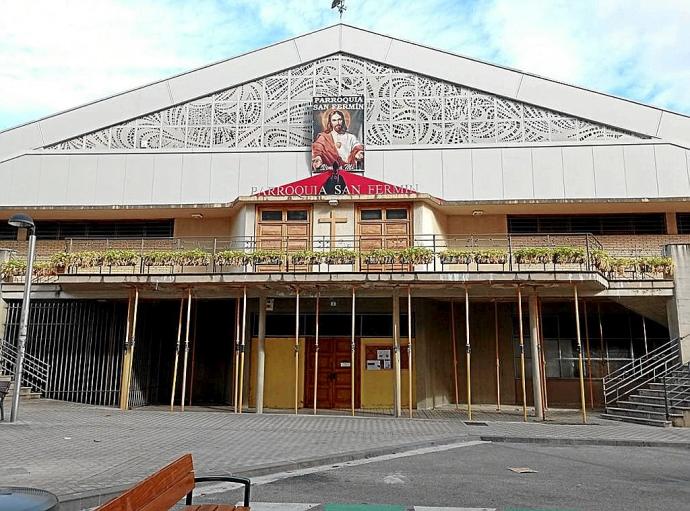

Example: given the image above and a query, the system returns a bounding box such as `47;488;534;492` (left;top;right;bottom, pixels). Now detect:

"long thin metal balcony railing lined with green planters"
0;233;669;280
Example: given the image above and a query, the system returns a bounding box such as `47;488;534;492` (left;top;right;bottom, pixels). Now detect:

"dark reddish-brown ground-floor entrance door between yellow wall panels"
304;337;360;409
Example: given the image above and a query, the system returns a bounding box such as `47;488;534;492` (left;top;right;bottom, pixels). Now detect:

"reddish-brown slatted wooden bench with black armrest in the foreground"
97;454;251;511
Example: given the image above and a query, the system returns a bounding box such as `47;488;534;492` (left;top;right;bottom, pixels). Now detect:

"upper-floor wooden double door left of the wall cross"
256;205;311;271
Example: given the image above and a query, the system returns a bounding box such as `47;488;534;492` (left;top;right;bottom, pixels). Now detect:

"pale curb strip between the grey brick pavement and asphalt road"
59;435;479;511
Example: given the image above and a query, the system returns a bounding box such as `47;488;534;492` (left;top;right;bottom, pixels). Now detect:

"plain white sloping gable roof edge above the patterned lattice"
0;24;690;160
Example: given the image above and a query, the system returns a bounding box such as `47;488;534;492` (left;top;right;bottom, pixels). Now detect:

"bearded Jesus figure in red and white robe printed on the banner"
311;110;364;171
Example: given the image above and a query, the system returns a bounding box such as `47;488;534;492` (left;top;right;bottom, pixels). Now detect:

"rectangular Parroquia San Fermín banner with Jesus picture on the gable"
311;96;364;173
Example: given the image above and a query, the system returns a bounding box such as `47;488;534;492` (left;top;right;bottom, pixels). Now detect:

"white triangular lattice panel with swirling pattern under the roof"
48;55;648;151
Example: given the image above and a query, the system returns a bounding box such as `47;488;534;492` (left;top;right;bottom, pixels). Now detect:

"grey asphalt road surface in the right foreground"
204;443;690;511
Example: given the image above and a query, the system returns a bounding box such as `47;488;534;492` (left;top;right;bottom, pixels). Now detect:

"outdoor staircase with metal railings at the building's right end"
601;339;690;427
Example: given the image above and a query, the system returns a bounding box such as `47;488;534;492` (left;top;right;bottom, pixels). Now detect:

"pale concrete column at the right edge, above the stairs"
664;244;690;364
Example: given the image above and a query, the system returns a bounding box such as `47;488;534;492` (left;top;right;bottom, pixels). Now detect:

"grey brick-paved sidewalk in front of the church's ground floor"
0;400;690;510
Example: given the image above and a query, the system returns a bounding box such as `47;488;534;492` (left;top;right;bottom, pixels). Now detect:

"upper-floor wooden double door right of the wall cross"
357;204;412;271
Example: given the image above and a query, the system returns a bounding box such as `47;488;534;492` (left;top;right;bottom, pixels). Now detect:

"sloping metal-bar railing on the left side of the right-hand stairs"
603;338;681;406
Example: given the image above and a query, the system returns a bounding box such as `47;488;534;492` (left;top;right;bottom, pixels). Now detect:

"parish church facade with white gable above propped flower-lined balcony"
0;25;690;414
